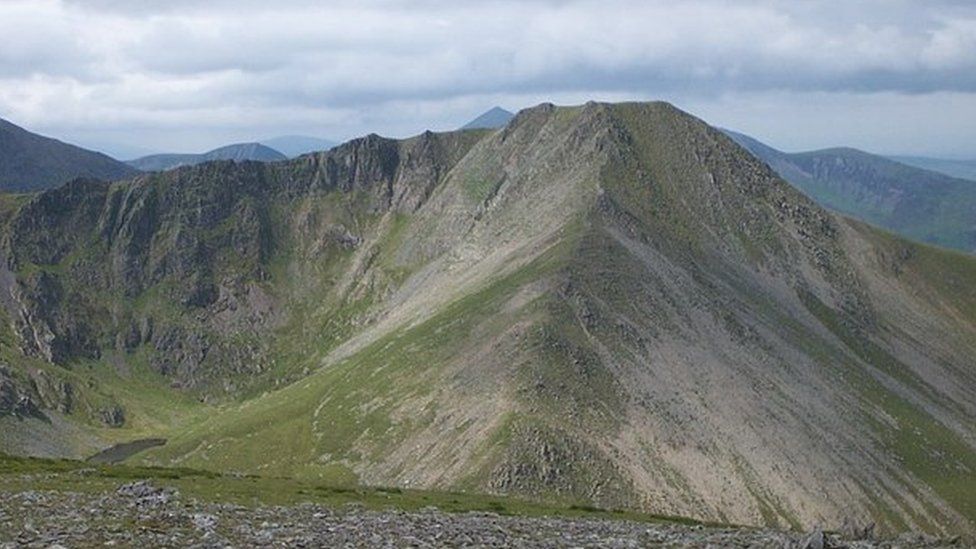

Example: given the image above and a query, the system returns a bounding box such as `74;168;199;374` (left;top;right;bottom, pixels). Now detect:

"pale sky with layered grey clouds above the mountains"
0;0;976;158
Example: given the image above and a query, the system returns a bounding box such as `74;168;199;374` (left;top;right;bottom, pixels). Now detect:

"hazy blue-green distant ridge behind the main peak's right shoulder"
725;130;976;253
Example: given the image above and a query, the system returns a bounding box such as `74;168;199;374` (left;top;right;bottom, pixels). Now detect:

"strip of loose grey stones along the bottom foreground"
0;481;959;549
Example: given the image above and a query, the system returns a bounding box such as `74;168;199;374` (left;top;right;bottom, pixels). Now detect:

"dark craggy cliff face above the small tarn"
3;129;486;394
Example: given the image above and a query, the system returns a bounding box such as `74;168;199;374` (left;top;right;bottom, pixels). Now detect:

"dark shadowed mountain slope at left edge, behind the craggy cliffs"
0;119;138;192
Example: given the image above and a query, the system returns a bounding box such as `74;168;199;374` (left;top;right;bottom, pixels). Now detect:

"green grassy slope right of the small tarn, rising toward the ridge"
145;240;572;482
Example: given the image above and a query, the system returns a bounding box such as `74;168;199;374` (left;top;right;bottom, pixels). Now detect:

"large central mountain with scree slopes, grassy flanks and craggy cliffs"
0;103;976;533
